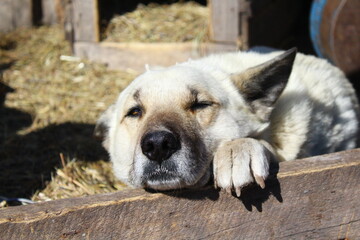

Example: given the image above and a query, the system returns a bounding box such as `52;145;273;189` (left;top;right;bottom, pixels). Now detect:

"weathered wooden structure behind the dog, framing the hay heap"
0;0;310;71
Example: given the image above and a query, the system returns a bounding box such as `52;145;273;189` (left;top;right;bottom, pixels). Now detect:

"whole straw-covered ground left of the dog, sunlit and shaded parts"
0;27;136;205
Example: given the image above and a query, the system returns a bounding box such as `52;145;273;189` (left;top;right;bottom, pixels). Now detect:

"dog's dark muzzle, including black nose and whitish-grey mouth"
138;129;210;190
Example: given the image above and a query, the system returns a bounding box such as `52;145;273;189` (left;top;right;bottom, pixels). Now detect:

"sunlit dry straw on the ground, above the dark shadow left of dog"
0;27;134;131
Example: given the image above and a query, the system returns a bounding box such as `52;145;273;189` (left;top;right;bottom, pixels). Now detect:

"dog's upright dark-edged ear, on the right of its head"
231;48;296;121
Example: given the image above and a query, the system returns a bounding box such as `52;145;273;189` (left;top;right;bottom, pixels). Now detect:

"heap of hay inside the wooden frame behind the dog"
103;2;209;43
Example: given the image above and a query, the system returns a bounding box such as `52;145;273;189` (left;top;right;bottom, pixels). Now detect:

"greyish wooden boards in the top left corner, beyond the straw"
0;0;33;32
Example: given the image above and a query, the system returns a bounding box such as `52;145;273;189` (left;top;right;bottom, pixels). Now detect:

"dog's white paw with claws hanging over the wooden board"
214;138;270;197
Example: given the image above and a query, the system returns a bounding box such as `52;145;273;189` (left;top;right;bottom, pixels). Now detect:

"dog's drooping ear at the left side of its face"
94;104;115;150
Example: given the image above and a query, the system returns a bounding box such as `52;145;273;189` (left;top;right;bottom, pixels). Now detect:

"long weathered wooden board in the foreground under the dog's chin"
0;149;360;240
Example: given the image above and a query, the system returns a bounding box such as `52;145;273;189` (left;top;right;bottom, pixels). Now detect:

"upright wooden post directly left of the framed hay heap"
72;0;100;42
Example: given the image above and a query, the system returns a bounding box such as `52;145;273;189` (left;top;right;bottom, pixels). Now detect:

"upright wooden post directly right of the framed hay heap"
209;0;241;43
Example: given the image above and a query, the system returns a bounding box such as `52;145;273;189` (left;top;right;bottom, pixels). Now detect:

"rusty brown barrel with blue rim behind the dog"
310;0;360;75
